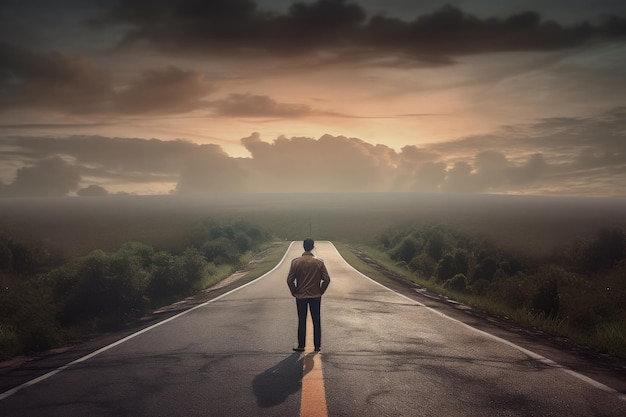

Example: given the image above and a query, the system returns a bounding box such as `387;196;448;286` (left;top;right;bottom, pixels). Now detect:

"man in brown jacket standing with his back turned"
287;238;330;352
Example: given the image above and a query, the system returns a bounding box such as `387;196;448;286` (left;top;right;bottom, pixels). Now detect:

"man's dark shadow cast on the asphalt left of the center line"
252;353;304;407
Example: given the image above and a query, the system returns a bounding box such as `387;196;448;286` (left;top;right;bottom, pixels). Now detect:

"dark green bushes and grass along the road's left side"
0;220;270;360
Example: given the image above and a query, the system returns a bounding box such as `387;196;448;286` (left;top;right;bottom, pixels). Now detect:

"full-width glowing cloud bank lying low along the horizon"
0;109;626;197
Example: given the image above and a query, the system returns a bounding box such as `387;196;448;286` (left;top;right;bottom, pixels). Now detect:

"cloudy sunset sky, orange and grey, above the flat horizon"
0;0;626;198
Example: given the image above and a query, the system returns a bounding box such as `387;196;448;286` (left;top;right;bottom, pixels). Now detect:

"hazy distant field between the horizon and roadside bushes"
0;193;626;256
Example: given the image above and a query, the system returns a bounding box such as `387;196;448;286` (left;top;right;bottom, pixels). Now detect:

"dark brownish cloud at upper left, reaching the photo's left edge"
0;43;214;115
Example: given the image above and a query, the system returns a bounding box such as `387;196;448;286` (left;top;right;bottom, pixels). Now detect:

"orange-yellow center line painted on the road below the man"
300;316;328;417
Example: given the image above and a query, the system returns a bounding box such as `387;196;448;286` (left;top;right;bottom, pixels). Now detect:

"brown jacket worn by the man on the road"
287;252;330;298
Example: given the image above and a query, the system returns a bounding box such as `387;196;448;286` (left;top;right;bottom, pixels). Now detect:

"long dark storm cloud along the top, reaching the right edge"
94;0;626;63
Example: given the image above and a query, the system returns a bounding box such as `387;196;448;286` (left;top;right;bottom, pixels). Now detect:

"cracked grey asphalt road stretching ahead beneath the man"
0;242;626;417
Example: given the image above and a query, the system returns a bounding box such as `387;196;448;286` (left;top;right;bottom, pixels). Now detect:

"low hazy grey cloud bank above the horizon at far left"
0;136;239;196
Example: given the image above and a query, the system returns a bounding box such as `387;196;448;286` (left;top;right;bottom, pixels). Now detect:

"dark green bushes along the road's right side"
346;224;626;358
